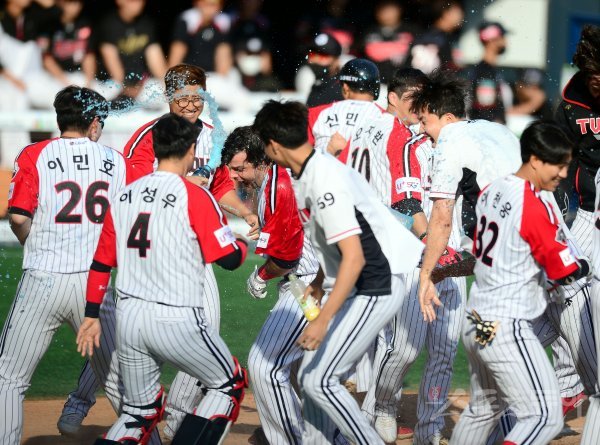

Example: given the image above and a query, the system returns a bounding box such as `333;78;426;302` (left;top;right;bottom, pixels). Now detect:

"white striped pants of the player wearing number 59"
299;275;405;445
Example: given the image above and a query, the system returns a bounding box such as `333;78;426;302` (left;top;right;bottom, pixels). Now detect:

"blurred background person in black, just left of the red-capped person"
410;0;465;74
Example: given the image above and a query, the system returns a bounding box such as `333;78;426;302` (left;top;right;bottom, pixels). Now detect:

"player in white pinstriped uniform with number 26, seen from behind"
0;87;126;445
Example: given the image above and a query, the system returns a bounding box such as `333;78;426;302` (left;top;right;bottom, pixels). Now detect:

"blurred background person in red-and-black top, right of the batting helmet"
361;0;418;83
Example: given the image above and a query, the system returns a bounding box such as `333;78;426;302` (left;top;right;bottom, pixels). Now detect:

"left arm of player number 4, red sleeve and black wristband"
76;208;117;357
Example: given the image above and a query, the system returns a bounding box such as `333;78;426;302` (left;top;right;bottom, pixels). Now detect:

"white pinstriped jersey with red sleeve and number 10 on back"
338;113;412;207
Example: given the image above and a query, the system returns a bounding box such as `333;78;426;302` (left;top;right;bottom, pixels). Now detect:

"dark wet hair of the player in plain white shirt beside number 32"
411;70;469;118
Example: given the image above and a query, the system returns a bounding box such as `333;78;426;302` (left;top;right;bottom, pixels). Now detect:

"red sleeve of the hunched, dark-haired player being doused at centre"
256;167;304;261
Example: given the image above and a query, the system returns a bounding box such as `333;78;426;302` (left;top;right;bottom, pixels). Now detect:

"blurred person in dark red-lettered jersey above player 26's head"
44;0;97;88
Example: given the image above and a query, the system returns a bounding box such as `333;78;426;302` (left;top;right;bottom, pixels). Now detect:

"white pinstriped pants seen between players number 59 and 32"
362;269;466;444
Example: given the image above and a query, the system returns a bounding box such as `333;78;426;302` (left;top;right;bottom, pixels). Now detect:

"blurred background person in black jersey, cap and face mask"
468;22;510;124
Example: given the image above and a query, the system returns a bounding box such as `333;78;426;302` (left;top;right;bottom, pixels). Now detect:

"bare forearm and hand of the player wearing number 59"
298;235;365;350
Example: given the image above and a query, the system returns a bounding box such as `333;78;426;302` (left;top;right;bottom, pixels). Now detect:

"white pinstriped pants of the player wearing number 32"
450;318;563;445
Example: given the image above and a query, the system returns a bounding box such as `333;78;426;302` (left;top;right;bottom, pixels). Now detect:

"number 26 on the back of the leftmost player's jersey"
54;181;108;224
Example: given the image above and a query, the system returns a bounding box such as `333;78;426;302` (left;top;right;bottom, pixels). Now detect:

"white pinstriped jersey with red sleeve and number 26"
8;138;126;273
